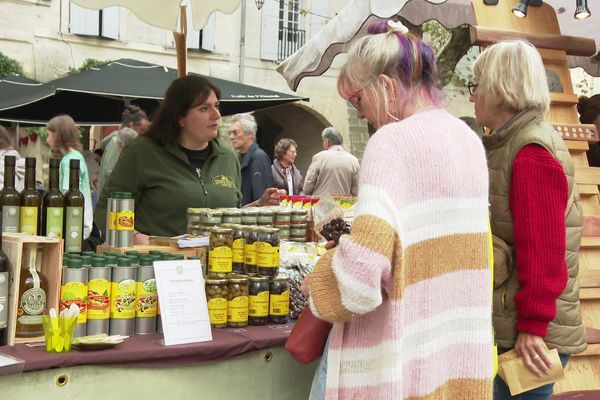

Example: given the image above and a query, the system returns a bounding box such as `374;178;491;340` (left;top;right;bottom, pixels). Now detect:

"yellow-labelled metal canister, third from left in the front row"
110;257;137;336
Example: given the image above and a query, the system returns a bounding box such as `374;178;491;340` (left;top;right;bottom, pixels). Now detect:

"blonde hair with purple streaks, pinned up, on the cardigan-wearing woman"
338;21;442;120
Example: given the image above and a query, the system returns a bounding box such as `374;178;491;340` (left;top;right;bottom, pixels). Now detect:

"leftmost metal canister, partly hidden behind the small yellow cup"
60;258;88;337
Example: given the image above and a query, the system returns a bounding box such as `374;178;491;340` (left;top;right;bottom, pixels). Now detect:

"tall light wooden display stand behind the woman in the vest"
471;0;600;393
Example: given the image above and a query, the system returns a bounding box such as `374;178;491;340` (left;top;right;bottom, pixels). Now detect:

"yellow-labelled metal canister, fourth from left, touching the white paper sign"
135;255;158;335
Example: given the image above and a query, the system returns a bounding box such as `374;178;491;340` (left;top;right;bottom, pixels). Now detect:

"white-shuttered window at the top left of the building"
69;3;119;39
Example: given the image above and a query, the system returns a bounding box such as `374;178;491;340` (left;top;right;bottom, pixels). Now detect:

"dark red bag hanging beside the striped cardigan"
285;306;333;364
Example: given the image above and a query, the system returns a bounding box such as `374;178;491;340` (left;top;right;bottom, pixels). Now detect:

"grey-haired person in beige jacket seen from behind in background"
304;126;360;196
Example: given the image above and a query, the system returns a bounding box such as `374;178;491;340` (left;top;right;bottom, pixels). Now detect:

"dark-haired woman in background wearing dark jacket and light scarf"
271;138;302;196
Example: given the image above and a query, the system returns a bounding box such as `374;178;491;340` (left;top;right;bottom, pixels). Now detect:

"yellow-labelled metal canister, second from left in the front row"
87;256;116;335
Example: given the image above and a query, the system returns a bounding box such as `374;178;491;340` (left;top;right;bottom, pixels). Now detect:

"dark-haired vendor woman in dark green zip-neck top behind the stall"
94;76;279;244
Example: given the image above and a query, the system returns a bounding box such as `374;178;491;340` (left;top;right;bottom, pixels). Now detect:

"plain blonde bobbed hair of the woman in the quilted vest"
473;40;550;114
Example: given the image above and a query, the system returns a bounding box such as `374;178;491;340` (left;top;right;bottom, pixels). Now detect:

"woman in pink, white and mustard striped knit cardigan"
303;21;493;400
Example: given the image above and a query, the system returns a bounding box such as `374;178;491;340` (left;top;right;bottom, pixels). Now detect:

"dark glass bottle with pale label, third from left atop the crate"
41;158;65;239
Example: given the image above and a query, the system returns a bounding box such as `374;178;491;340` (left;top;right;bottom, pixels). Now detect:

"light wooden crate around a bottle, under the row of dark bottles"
2;233;63;346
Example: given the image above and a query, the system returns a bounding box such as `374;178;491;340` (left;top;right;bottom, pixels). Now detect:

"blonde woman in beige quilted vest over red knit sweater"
470;41;586;400
